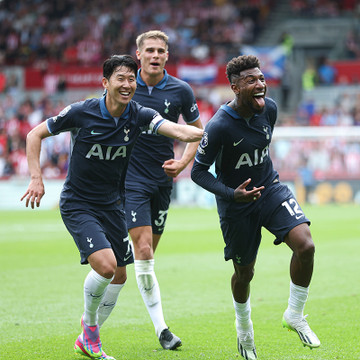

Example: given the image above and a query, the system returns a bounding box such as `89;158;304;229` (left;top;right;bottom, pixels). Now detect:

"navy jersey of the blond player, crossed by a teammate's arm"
126;69;200;186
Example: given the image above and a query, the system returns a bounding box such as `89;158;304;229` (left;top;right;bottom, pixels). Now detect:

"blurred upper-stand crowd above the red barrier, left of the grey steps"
0;0;276;67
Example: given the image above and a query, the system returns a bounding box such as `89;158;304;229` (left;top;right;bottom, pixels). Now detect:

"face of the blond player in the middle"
136;38;169;86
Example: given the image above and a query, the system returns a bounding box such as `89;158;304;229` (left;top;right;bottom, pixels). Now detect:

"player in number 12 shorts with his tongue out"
191;55;320;359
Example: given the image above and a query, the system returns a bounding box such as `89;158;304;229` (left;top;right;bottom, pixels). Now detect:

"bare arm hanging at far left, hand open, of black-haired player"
20;122;51;209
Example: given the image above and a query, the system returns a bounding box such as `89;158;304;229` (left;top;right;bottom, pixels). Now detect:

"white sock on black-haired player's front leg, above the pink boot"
83;269;112;326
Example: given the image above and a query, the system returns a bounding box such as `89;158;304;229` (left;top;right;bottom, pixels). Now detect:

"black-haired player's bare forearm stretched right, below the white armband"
157;120;204;142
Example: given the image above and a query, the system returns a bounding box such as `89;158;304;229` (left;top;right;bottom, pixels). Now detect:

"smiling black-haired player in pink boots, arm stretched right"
21;55;203;359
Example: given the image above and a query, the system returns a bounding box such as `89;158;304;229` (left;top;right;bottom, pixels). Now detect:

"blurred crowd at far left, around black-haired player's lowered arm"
0;94;70;178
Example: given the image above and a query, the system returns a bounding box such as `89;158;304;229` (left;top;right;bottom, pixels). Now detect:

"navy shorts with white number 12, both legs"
219;183;310;266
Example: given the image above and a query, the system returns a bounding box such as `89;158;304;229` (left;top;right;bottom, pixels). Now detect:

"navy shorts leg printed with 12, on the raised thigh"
262;184;310;243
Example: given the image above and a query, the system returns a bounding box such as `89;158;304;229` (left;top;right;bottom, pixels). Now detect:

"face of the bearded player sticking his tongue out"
231;67;266;117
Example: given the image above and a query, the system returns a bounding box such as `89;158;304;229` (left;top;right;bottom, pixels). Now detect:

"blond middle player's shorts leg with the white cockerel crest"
125;184;153;229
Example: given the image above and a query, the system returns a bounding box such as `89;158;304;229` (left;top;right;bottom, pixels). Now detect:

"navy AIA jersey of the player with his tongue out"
195;98;278;212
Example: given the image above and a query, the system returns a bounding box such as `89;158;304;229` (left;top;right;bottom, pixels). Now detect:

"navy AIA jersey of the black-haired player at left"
46;97;161;208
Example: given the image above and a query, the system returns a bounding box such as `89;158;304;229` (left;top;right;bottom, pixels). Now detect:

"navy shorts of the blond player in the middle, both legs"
125;183;172;235
